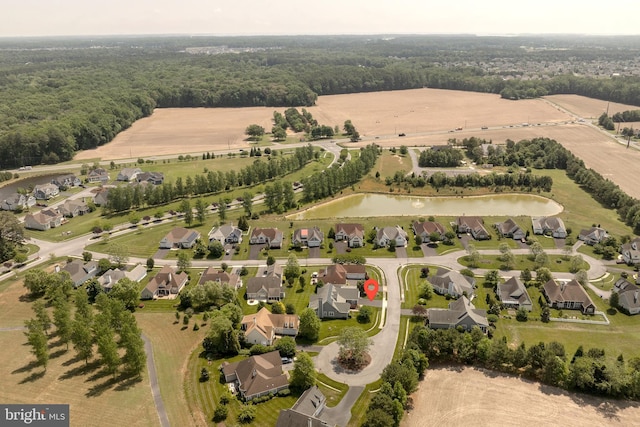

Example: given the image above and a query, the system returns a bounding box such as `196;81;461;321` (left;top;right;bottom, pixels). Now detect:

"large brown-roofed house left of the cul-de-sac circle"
220;350;289;400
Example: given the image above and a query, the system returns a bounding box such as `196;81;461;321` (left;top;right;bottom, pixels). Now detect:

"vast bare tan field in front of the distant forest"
76;89;640;198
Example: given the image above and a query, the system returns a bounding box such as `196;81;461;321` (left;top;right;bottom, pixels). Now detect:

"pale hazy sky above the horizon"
0;0;640;37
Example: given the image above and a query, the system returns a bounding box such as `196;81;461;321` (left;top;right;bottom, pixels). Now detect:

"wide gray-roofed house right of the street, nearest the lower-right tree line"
427;296;489;333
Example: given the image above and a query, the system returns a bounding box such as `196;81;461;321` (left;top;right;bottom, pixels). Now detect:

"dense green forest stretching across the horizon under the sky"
0;36;640;168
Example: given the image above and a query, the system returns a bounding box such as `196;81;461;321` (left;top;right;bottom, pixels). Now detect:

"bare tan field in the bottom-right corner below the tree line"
400;368;640;427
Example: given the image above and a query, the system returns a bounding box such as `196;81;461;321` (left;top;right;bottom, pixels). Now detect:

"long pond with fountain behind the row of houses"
289;194;563;220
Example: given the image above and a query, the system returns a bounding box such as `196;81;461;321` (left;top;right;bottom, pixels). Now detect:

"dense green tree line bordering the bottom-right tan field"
407;325;640;399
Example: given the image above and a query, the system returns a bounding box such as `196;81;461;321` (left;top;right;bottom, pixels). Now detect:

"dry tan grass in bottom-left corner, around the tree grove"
0;281;160;427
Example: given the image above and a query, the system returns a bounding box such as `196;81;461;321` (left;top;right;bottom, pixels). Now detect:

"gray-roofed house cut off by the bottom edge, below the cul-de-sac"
276;385;335;427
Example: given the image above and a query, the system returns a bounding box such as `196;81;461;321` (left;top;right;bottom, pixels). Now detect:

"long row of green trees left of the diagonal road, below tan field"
104;145;316;213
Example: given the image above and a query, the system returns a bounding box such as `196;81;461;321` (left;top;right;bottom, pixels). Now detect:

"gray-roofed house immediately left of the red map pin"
309;284;360;319
